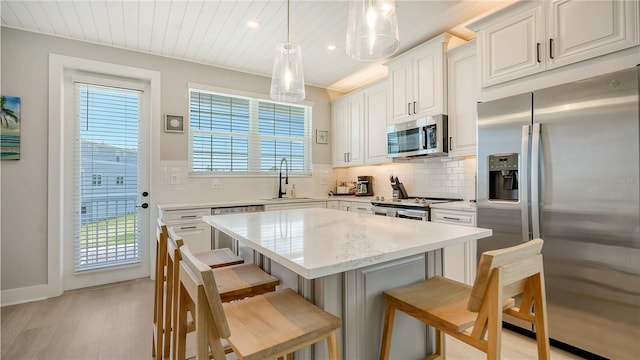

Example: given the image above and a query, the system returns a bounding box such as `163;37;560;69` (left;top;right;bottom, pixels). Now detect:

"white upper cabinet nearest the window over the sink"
331;92;364;167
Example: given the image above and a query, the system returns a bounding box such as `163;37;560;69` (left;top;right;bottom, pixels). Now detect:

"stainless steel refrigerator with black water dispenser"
477;67;640;359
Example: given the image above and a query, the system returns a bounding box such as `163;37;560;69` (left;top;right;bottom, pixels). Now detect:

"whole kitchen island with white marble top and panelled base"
203;208;492;359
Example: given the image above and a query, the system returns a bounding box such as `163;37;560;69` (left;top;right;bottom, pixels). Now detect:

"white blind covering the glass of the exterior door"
74;82;141;271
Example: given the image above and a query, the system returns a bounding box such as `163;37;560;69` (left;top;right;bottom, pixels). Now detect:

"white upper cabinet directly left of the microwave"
364;81;391;164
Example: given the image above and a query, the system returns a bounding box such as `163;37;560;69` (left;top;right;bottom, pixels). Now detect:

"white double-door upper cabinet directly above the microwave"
386;33;463;124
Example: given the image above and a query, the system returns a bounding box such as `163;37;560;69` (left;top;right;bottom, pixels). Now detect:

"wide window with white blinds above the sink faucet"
189;89;312;175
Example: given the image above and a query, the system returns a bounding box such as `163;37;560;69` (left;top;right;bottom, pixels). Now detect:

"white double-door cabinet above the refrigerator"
468;0;639;87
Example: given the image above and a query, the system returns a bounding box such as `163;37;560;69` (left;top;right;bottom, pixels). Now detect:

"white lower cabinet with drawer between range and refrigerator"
431;208;476;285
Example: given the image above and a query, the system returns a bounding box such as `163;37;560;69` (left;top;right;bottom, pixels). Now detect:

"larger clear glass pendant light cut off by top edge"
346;0;400;61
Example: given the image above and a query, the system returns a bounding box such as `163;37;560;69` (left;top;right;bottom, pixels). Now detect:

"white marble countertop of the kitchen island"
203;208;492;279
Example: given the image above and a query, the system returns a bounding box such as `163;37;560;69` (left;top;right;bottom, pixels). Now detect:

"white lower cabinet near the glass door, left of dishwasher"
160;207;212;252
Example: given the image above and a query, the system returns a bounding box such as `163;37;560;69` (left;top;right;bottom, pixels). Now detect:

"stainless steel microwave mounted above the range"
387;115;449;158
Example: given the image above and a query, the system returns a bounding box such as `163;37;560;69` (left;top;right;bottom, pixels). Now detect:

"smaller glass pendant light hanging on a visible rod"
270;0;305;102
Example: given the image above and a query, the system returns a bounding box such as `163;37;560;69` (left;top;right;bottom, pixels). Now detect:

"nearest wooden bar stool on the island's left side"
176;246;342;360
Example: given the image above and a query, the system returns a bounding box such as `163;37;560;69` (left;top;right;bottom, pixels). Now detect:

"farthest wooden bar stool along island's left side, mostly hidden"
151;219;244;359
